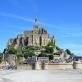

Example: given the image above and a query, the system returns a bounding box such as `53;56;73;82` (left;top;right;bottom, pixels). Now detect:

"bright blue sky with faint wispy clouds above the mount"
0;0;82;56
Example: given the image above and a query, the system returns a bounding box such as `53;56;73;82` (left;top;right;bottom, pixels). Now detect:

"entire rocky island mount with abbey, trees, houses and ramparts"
2;18;82;70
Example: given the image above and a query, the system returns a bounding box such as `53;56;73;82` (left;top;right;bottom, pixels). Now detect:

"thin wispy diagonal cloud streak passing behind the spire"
0;12;62;30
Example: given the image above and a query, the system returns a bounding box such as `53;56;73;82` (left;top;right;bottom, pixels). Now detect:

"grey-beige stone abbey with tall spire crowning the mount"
8;18;55;48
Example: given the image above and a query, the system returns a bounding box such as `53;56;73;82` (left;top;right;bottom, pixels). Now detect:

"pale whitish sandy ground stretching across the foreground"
0;70;82;82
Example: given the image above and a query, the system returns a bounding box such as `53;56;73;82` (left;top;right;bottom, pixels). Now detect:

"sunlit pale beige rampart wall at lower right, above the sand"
36;62;82;70
